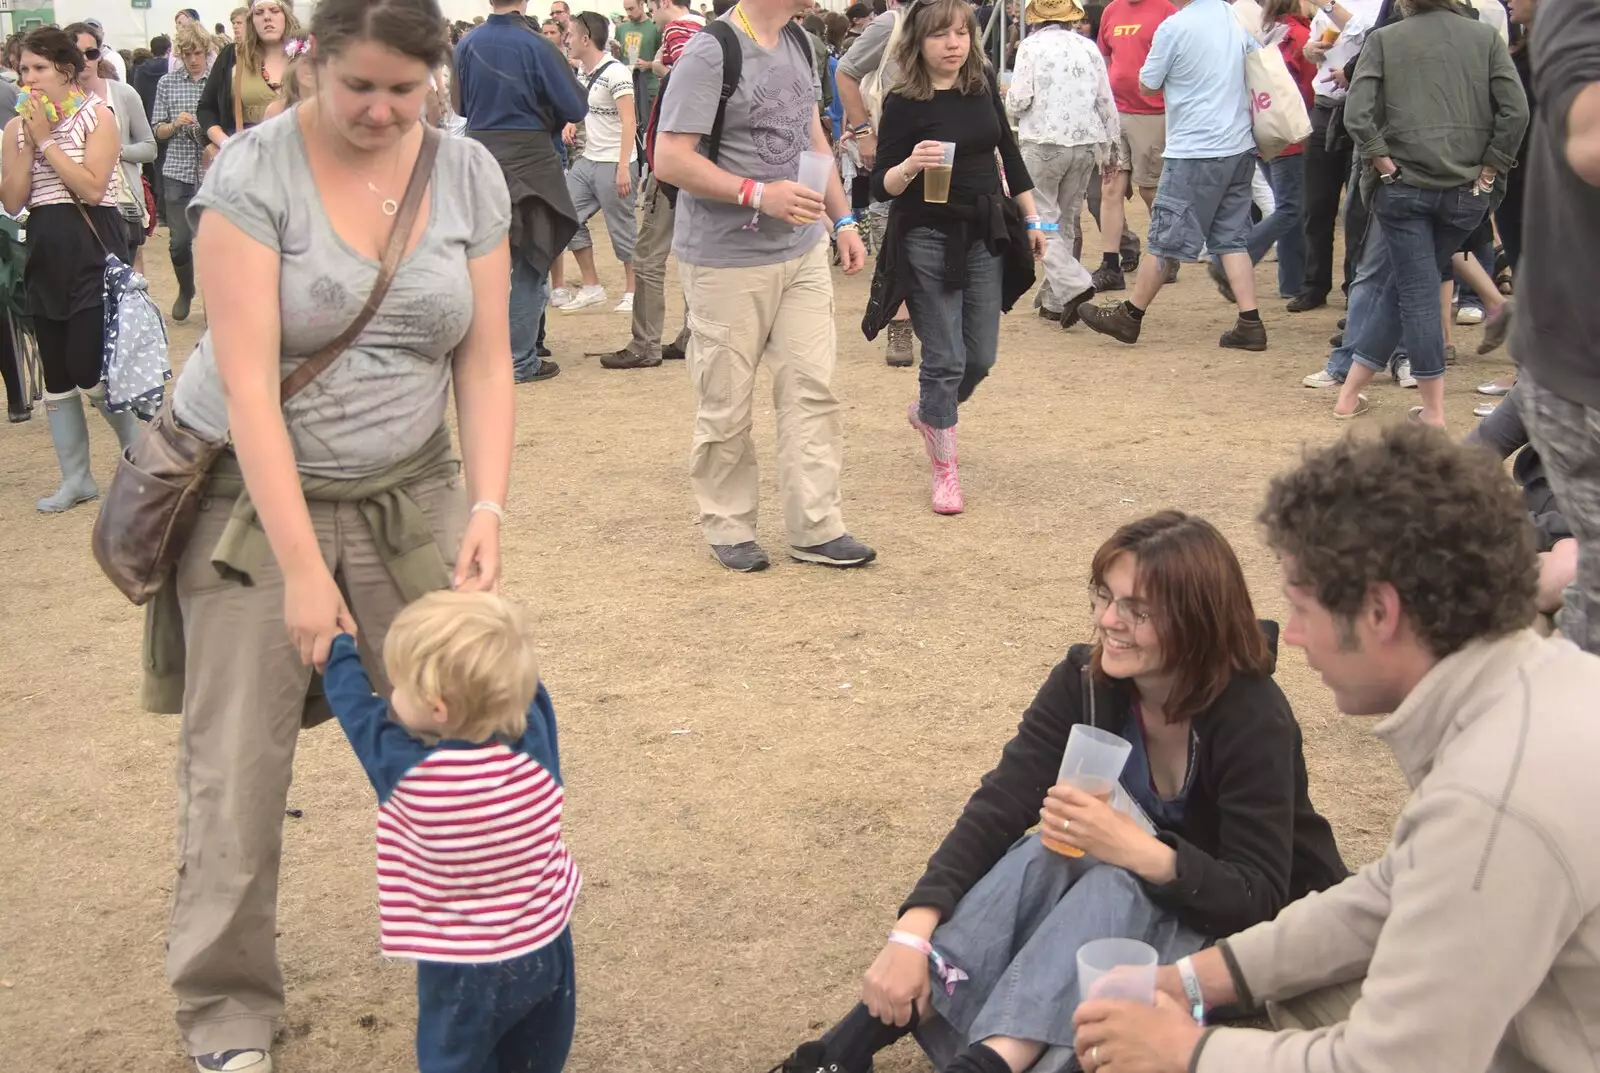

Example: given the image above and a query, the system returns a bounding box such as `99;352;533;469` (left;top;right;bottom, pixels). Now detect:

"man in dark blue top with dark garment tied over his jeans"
456;0;589;384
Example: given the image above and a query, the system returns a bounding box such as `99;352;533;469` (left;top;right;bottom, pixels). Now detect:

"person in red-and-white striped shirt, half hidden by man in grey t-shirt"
600;0;704;369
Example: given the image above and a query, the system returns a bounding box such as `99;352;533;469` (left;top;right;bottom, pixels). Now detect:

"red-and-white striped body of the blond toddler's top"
378;742;581;963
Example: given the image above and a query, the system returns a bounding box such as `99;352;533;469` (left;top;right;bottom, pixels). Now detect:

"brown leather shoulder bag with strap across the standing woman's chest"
93;126;438;604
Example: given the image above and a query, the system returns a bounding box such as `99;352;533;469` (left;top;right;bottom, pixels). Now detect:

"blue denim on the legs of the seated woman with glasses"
917;833;1208;1073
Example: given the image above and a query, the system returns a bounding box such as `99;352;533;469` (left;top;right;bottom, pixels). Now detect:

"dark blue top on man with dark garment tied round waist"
456;14;589;134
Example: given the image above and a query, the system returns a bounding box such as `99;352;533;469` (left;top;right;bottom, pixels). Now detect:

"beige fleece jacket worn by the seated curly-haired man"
1192;630;1600;1073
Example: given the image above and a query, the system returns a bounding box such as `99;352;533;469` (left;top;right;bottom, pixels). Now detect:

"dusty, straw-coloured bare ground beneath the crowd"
0;203;1509;1073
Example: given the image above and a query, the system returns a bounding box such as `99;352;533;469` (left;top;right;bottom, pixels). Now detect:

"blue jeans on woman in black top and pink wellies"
901;227;1000;429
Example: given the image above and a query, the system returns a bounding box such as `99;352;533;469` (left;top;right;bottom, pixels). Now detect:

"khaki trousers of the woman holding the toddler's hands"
166;475;467;1054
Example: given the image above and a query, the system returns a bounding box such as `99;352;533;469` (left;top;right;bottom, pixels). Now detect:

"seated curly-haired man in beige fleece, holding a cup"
1077;424;1600;1073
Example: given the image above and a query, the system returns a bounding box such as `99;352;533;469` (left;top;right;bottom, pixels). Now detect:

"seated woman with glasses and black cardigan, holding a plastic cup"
773;510;1346;1073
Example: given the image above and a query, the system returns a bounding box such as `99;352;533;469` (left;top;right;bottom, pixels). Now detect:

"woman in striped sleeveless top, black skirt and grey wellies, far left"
0;27;136;513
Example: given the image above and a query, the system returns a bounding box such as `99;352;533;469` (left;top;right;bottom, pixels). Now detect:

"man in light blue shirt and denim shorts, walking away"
1078;0;1267;350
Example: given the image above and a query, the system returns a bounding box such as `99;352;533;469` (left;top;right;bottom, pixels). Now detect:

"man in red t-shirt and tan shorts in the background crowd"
1093;0;1178;293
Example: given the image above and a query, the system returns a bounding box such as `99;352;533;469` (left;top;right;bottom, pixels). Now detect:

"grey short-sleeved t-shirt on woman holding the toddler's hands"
173;109;510;478
